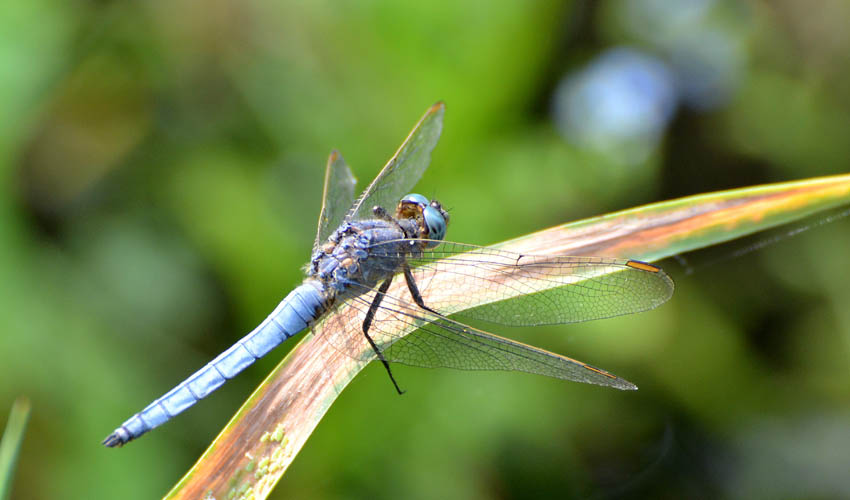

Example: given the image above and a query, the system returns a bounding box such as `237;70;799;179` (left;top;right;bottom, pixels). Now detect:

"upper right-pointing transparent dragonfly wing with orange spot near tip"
370;242;674;326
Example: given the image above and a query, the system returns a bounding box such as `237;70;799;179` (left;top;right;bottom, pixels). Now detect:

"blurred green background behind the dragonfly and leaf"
0;0;850;499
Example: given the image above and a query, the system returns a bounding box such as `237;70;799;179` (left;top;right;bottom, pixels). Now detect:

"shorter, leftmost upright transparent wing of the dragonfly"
313;151;357;251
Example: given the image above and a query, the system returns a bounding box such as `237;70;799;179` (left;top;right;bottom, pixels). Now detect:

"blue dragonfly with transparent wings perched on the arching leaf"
103;102;674;447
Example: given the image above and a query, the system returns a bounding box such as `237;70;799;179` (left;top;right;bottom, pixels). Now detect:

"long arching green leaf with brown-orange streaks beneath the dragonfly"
166;175;850;498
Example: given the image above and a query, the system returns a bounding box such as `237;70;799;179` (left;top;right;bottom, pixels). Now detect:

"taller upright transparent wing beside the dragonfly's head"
346;102;446;220
